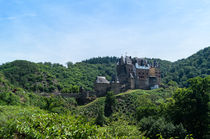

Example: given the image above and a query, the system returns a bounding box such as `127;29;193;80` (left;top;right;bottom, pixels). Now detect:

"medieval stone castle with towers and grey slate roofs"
95;56;161;96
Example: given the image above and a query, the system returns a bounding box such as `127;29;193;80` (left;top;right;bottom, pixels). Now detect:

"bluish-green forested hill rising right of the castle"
163;47;210;87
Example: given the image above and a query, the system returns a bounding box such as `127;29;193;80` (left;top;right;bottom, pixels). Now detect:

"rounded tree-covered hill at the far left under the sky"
0;60;57;92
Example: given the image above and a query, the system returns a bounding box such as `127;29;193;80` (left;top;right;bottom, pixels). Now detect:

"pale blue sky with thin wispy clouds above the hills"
0;0;210;64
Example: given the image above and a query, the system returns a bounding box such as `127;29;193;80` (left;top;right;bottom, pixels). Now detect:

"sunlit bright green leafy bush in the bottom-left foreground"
0;106;97;139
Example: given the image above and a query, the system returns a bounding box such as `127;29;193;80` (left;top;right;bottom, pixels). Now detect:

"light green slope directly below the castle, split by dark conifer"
78;87;175;119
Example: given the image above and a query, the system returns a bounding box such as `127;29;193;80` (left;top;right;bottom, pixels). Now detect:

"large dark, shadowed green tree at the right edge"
167;76;210;138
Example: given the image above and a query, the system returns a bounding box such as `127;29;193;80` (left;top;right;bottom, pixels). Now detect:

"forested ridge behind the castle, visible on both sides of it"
0;47;210;92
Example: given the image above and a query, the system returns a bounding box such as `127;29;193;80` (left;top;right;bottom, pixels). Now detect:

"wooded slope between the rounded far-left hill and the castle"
39;62;115;91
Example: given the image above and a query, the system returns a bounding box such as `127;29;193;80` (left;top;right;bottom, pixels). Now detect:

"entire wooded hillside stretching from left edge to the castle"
0;60;115;93
